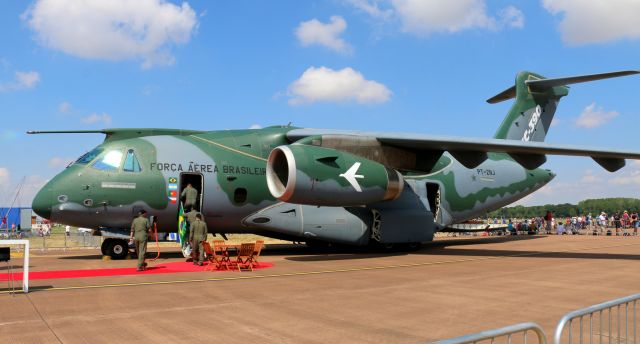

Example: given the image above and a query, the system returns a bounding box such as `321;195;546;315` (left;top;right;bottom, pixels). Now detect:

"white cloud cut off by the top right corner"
542;0;640;45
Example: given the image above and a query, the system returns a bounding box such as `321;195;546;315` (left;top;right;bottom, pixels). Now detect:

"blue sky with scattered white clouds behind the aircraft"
0;0;640;205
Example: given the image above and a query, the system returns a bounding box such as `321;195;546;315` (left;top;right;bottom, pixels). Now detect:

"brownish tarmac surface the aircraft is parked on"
0;236;640;343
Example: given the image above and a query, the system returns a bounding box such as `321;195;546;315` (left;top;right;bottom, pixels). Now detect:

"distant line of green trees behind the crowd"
487;198;640;218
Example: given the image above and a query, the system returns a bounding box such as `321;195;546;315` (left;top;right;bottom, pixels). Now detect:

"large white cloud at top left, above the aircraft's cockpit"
22;0;197;68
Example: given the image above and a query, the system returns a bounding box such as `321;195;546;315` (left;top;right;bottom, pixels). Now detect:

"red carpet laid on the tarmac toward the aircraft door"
0;261;273;281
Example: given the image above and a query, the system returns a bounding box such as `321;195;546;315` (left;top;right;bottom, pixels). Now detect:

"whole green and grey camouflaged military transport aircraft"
29;71;640;258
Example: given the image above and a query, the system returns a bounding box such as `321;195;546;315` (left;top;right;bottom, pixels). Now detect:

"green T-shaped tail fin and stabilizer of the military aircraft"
487;70;640;142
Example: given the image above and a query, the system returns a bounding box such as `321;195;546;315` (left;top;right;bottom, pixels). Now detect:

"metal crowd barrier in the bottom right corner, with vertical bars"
553;294;640;344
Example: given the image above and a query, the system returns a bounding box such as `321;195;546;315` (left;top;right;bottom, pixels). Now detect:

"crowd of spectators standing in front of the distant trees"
488;210;640;236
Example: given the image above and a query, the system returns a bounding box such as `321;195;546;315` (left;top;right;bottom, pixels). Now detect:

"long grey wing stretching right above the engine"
287;129;640;172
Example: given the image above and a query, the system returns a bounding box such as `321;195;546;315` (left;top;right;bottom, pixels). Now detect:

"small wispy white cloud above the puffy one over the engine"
296;16;352;53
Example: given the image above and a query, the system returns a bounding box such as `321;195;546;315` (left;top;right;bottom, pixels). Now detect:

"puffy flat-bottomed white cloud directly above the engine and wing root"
287;67;392;105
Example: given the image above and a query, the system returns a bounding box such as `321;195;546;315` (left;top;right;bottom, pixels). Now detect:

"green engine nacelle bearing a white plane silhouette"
267;144;404;206
